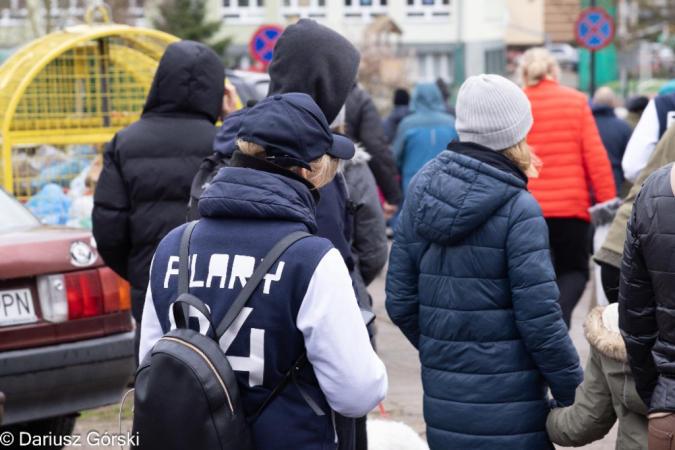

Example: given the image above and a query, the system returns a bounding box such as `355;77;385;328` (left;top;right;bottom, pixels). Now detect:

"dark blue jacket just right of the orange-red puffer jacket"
593;105;633;192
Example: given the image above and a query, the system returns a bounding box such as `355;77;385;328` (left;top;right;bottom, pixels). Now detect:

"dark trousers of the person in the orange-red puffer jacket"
546;218;590;329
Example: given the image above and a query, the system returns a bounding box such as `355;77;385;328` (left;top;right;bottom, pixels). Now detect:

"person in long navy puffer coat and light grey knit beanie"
386;75;583;450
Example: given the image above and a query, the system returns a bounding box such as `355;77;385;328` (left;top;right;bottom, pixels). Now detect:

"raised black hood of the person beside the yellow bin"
143;41;225;124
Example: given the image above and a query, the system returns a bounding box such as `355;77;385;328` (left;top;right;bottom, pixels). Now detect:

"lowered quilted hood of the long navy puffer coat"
406;142;527;245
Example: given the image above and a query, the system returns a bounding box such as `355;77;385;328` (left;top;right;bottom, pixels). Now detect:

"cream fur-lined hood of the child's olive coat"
584;305;628;362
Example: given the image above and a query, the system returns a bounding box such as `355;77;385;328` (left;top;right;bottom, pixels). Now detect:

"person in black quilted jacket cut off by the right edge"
619;163;675;449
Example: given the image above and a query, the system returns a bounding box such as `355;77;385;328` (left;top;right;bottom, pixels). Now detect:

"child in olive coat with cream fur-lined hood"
546;303;647;450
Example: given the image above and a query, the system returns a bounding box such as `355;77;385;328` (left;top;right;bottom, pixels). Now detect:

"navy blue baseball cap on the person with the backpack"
237;92;354;170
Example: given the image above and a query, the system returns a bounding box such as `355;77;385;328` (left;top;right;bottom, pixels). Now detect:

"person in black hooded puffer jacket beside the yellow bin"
92;41;225;344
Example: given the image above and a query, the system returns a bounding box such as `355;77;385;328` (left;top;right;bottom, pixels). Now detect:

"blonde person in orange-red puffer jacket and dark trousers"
520;48;616;328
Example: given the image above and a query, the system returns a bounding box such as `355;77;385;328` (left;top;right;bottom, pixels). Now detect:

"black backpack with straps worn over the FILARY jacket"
132;221;324;450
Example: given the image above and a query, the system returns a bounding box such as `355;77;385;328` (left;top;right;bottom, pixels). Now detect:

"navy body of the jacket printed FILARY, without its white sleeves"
151;157;336;450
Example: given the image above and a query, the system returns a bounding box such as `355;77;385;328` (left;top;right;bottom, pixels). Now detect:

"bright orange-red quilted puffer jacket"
525;80;616;221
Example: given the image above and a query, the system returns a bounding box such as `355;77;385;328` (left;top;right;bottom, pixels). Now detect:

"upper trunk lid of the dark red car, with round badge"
0;225;103;279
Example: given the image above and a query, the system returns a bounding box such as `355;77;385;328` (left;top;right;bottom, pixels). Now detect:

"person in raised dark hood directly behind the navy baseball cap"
213;19;368;450
